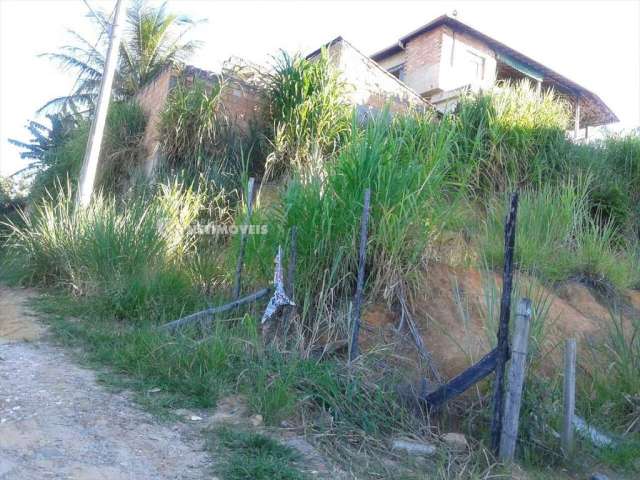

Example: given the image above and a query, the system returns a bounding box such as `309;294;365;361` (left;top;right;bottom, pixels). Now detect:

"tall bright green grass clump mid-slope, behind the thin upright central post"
247;114;451;337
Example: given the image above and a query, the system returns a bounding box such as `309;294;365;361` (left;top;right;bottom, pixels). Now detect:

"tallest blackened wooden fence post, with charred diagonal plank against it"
491;192;518;455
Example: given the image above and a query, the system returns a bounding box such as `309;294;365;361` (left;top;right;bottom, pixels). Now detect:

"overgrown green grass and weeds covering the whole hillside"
3;46;640;478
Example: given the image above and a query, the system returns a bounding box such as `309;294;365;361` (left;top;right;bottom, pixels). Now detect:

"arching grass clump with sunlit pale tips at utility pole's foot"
6;180;201;318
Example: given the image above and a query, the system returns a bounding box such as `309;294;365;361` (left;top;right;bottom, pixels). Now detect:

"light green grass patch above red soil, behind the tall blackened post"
481;178;637;289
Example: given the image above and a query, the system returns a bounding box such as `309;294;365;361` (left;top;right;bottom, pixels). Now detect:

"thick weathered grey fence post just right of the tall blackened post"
499;298;531;462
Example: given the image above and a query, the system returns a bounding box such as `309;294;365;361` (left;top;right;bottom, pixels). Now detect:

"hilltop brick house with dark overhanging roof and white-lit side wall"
371;15;618;139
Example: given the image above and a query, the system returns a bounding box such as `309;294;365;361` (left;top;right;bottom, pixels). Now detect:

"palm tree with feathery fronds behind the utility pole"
39;0;201;113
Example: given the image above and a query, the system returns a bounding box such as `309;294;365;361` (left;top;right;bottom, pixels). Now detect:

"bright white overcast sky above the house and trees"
0;0;640;175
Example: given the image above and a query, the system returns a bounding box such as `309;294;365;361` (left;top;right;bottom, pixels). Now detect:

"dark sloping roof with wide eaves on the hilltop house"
371;15;619;126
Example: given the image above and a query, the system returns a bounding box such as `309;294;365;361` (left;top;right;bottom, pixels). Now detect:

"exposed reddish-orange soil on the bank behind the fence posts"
362;263;640;378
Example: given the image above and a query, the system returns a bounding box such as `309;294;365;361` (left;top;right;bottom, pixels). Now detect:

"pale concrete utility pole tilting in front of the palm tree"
77;0;128;207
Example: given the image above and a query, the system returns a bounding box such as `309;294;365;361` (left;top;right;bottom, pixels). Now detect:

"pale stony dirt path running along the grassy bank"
0;286;214;480
